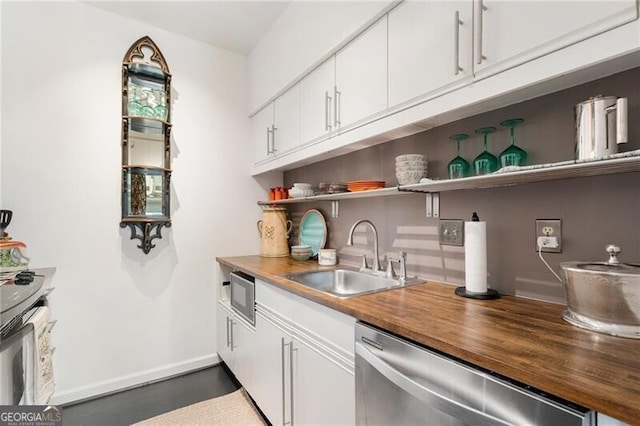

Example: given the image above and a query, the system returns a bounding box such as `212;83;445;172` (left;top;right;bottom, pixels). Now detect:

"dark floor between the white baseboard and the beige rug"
62;364;240;426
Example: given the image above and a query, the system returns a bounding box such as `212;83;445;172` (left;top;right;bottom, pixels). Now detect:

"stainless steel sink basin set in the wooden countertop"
284;268;420;298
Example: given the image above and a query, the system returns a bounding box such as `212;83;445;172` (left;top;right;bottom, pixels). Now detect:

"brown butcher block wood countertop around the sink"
217;256;640;424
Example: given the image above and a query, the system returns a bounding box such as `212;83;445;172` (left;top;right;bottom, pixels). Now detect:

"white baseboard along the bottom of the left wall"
49;354;220;405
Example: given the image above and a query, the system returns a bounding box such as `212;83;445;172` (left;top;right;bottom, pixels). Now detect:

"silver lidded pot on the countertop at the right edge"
560;244;640;339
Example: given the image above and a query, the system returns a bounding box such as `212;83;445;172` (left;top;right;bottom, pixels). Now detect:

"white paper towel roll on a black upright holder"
464;222;487;293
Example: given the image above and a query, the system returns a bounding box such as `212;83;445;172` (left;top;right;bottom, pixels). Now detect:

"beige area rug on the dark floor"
133;388;266;426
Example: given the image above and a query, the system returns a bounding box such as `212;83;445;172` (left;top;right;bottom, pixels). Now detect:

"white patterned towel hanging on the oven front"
29;306;55;405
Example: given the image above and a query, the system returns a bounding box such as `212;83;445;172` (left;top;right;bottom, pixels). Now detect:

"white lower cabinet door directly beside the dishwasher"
292;339;356;425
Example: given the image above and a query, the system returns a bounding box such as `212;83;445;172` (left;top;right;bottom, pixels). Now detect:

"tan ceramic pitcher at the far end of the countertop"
258;207;293;257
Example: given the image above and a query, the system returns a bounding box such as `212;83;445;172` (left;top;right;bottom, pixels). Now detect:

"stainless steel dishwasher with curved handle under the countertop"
355;323;596;426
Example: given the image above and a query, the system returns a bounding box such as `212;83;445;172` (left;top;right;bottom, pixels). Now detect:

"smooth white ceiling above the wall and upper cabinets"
87;0;289;55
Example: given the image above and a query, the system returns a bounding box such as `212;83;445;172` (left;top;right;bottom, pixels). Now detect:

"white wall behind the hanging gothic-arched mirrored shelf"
0;2;265;403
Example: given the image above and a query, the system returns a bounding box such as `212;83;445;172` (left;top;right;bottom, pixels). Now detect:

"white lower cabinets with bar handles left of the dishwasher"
216;279;355;425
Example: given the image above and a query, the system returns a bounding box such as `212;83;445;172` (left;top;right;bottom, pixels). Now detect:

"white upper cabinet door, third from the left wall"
300;56;336;143
